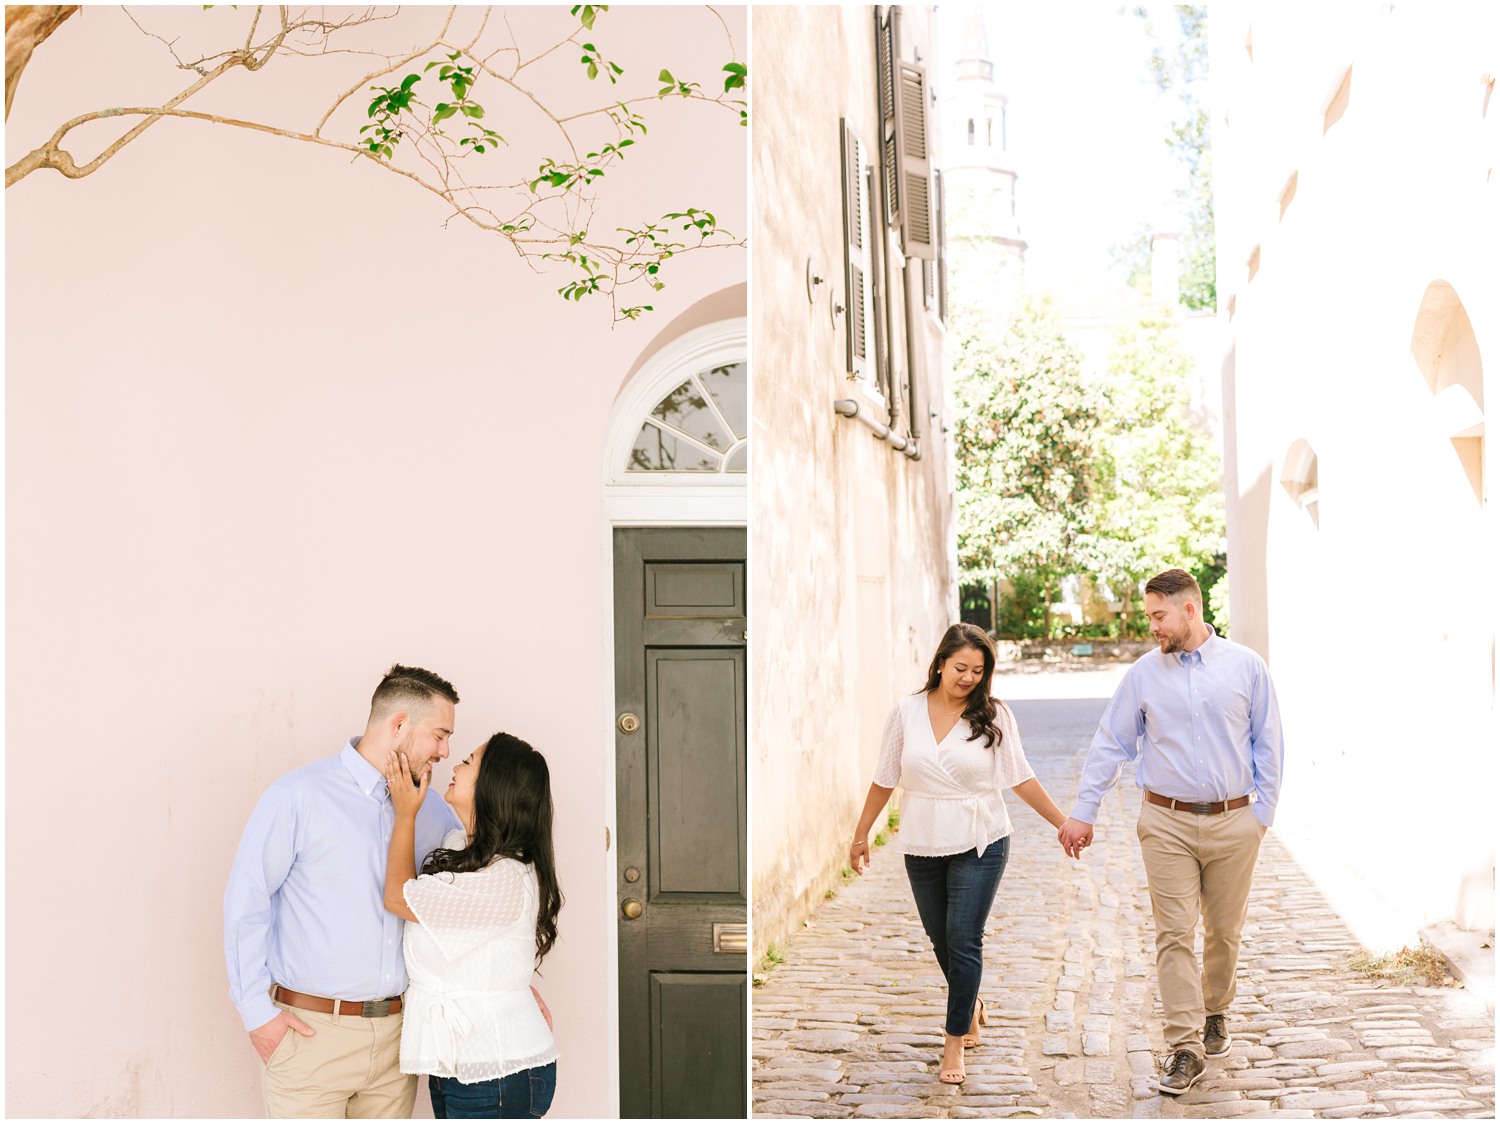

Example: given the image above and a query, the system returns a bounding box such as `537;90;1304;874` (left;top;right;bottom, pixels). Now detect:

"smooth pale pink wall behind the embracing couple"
6;6;749;1116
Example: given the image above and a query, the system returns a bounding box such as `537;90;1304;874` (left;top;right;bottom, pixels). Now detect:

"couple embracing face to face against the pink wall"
224;665;563;1118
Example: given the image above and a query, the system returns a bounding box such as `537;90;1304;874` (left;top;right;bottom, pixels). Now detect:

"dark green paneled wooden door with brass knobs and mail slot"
615;528;749;1118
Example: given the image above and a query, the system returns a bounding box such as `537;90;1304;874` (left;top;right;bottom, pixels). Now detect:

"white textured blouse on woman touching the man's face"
401;830;558;1082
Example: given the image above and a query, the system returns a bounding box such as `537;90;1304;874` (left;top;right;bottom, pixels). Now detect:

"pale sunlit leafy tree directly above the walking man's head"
1094;320;1224;630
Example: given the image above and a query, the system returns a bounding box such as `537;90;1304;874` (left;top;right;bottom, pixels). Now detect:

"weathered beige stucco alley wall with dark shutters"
750;6;957;953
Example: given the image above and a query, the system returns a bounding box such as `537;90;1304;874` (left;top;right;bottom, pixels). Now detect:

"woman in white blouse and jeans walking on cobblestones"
849;624;1067;1085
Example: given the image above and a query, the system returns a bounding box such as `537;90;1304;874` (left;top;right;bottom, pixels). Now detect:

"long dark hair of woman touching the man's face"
422;734;563;963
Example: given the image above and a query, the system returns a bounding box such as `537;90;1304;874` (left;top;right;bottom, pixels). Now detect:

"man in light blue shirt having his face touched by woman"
224;665;459;1118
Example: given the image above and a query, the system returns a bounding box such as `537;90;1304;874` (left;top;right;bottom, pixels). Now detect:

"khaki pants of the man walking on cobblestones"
1136;801;1262;1059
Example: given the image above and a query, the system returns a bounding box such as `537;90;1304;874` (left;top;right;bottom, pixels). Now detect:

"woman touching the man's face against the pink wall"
386;734;563;1119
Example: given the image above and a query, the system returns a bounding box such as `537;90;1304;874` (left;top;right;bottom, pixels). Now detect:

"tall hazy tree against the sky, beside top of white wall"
1110;5;1218;311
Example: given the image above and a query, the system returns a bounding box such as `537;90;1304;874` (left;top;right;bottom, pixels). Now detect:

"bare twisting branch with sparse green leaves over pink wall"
6;5;749;321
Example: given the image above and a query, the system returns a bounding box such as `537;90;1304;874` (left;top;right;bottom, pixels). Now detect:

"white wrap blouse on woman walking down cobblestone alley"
875;692;1037;855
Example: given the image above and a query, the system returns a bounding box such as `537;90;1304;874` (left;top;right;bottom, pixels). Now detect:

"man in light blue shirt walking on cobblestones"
1058;570;1281;1095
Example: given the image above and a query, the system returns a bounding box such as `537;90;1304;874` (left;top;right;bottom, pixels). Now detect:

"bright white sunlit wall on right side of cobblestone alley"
1212;3;1500;942
